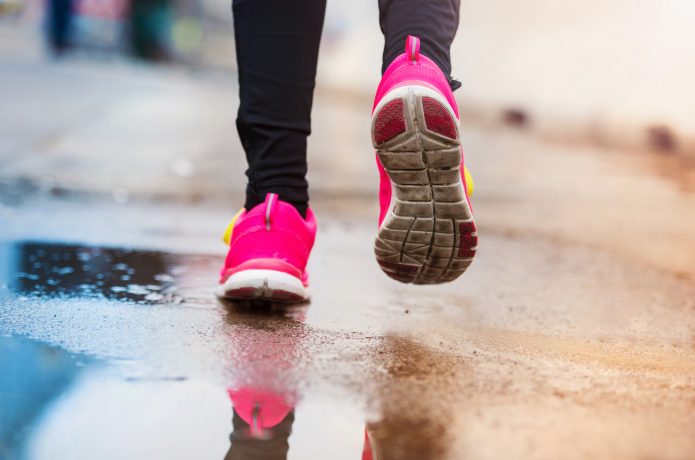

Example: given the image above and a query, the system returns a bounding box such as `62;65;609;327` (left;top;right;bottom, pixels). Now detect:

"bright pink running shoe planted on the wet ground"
216;193;316;303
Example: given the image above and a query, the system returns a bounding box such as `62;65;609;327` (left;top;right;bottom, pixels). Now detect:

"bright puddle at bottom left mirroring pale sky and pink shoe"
0;330;365;460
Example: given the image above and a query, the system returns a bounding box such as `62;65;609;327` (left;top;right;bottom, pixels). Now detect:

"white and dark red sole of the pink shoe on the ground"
215;270;309;303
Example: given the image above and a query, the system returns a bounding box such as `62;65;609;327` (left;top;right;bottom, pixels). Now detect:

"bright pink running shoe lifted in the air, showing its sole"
372;36;478;284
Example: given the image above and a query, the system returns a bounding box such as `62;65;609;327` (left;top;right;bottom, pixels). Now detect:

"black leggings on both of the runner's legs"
232;0;460;215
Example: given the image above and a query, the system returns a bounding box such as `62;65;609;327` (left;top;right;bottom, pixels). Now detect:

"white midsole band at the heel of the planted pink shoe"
215;269;309;299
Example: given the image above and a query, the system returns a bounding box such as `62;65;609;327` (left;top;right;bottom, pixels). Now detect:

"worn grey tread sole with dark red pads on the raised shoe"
372;89;478;284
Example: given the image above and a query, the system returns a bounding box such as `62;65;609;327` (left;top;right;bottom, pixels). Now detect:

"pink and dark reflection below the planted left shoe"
223;301;306;460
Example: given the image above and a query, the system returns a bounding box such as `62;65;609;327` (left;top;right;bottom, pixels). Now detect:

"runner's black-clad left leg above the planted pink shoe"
232;0;326;216
